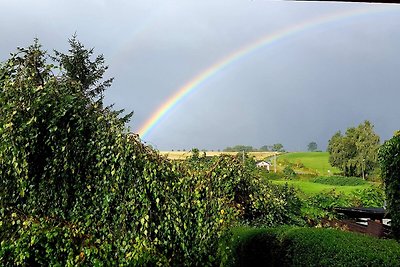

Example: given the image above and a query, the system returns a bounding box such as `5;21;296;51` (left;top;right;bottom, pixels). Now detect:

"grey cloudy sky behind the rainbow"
0;0;400;151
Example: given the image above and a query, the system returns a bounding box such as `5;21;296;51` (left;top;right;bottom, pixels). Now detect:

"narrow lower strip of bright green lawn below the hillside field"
271;180;370;196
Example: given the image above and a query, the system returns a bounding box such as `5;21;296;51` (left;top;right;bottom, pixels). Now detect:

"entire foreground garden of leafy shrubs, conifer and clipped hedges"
0;37;400;266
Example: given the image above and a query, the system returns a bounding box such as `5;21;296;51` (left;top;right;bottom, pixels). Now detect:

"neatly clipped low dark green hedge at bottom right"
223;227;400;266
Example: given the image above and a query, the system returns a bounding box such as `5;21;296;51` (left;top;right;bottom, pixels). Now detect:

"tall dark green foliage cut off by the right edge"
379;132;400;240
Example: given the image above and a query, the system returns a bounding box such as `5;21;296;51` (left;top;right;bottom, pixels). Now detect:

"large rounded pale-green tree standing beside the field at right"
327;121;380;178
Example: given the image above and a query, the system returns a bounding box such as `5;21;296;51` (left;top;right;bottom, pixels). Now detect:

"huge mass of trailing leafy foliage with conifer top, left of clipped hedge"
0;39;300;266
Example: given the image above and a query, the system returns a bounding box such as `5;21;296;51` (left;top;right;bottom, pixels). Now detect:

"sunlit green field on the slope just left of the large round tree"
278;152;340;176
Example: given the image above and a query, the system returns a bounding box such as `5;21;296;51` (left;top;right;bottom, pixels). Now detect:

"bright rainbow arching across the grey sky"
138;5;400;139
